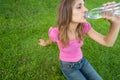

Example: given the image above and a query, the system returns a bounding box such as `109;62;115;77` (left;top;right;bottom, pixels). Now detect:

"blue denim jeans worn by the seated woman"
60;57;103;80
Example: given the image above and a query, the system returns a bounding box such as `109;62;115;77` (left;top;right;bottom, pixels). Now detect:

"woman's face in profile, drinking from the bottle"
72;0;88;23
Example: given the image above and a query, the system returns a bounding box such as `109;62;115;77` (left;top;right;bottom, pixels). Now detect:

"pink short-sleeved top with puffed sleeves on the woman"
48;22;91;62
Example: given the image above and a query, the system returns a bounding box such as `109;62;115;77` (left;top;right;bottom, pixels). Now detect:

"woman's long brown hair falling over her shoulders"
57;0;84;47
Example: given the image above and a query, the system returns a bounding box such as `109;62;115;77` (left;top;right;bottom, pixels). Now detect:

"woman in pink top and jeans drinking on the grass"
39;0;120;80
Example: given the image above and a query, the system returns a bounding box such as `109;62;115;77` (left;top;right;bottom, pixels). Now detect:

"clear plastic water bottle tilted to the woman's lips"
85;3;120;19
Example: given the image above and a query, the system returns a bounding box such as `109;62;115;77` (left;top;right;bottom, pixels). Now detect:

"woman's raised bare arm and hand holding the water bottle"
88;2;120;47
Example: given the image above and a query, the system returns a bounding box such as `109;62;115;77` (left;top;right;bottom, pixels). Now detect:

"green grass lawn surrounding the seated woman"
0;0;120;80
